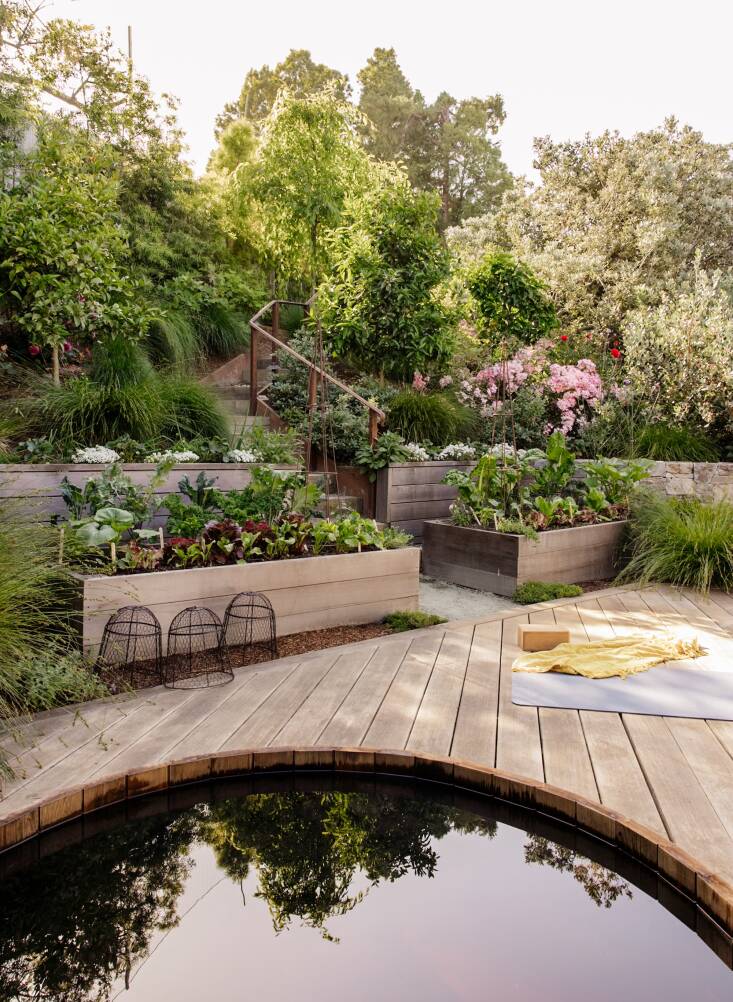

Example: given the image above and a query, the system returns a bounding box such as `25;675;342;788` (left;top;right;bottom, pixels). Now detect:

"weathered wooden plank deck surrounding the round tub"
0;587;733;882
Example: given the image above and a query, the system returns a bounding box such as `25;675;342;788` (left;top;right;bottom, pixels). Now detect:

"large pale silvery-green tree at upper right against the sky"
449;119;733;340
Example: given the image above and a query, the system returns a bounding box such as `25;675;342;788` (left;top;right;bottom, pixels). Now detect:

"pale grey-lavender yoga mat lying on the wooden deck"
512;658;733;720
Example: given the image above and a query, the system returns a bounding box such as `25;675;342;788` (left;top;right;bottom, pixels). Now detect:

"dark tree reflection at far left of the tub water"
0;816;195;1002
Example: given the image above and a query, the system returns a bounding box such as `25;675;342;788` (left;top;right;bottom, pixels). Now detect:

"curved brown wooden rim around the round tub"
0;747;733;933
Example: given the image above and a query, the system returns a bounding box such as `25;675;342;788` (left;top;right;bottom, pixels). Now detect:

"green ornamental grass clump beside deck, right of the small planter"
619;492;733;592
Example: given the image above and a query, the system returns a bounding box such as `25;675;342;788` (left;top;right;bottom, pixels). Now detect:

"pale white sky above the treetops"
53;0;733;173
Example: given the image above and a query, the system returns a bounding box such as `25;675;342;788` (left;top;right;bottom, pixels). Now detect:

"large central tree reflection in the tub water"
202;793;496;939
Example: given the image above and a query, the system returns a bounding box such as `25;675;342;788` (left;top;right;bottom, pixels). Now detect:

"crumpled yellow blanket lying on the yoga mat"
512;633;705;678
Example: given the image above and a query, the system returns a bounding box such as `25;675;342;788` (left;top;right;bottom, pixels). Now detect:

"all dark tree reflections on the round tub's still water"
0;792;708;1002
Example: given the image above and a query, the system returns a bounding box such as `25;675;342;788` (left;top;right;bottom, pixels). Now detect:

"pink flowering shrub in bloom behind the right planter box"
457;340;605;435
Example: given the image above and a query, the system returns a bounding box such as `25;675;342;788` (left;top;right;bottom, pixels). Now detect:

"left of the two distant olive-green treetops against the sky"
216;49;351;138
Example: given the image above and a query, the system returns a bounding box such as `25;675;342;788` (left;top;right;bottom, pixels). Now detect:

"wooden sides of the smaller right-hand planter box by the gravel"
423;520;626;595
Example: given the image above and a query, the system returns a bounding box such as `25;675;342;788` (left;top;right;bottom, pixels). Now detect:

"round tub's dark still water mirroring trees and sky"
0;774;733;1002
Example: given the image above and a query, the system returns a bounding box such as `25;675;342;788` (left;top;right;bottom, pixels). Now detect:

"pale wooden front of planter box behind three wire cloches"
74;547;420;655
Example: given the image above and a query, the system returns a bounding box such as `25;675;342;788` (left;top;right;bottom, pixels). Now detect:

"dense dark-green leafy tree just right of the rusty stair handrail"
318;171;453;379
